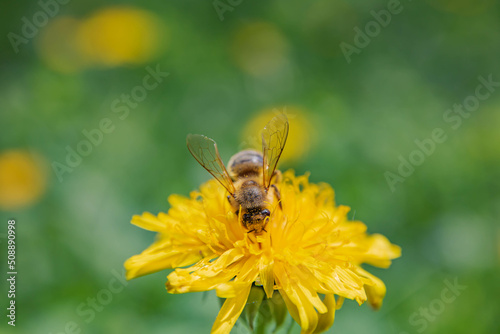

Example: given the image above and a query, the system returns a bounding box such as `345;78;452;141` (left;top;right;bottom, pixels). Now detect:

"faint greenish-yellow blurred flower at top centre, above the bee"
231;22;288;76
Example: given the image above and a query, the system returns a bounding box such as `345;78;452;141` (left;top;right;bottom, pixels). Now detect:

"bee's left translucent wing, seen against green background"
186;134;235;195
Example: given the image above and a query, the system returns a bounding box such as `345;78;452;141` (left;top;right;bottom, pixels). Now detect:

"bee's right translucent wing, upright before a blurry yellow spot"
262;114;289;189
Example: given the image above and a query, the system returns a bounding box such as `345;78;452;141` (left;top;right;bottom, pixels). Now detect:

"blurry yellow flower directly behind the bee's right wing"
241;107;315;162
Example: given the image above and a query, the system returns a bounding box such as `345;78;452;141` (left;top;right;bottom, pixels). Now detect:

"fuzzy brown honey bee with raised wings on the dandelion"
187;114;289;235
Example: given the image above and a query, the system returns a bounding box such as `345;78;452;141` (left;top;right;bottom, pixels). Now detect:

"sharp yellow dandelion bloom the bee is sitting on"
125;171;401;333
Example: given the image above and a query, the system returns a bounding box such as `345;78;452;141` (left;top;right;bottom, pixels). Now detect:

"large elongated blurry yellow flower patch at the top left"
37;7;166;73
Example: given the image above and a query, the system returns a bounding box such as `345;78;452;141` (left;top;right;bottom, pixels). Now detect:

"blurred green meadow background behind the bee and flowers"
0;0;500;334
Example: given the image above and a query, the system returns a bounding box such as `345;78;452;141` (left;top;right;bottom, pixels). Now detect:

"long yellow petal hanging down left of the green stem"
210;284;252;334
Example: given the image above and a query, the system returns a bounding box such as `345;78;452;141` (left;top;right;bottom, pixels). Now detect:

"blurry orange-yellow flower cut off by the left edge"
0;150;47;210
